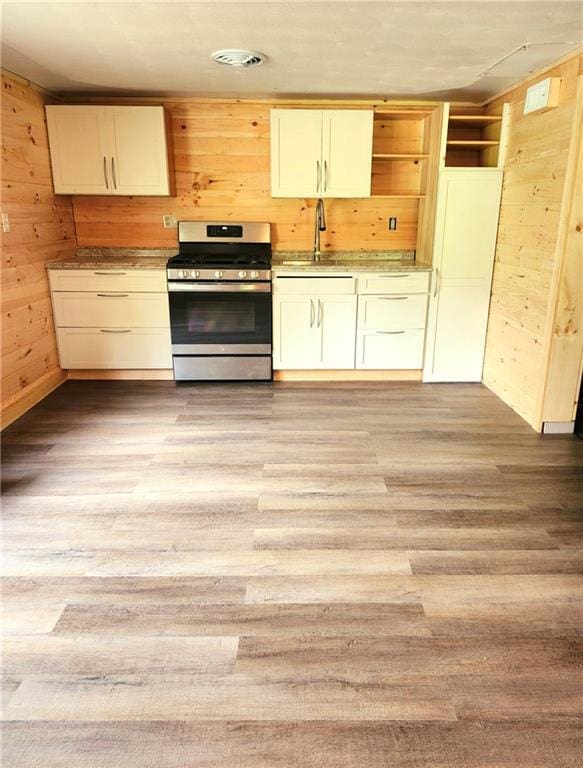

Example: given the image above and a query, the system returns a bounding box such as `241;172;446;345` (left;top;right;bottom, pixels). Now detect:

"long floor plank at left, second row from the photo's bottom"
5;673;457;721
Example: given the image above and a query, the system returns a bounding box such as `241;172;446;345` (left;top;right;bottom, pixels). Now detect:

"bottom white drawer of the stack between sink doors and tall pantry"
356;329;425;370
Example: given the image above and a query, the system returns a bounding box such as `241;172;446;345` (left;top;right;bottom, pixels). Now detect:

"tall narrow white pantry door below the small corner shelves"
423;168;502;381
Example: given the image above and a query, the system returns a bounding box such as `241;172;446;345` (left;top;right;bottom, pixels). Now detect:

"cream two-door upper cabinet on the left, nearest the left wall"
46;105;170;195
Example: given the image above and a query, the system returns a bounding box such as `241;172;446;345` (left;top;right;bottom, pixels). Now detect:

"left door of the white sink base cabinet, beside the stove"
273;294;317;369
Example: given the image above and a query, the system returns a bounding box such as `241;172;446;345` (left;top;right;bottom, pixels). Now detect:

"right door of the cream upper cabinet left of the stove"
105;107;170;195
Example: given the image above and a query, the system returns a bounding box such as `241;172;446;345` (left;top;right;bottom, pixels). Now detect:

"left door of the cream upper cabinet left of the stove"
45;105;113;195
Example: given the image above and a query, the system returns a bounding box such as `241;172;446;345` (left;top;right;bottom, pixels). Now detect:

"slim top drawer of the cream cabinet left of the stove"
49;269;168;293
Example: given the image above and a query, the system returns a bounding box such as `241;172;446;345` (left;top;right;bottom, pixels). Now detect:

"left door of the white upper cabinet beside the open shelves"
271;109;323;197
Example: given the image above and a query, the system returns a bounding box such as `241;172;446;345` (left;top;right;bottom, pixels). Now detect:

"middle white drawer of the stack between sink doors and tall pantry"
358;293;427;331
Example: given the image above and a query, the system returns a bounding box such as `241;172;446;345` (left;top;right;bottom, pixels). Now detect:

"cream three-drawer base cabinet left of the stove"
49;269;172;370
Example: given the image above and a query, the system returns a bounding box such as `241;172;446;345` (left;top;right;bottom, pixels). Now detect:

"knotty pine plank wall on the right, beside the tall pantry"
484;57;582;429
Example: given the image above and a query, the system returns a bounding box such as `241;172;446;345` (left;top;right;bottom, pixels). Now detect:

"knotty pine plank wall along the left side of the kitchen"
1;72;77;420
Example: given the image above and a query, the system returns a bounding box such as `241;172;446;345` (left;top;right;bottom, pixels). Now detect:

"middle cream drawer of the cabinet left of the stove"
53;291;170;328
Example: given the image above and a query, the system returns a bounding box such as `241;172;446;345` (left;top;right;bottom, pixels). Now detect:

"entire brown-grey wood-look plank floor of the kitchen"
2;382;583;768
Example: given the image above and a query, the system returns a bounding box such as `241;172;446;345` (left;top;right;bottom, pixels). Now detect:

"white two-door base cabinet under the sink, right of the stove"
273;276;356;370
